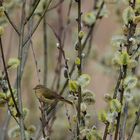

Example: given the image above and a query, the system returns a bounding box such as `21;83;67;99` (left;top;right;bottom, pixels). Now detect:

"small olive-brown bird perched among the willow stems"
33;85;73;105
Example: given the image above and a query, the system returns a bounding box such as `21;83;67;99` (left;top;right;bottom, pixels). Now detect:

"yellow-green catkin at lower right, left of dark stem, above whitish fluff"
110;99;121;112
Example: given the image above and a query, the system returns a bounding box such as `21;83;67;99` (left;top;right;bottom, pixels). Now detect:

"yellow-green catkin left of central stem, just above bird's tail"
69;80;79;92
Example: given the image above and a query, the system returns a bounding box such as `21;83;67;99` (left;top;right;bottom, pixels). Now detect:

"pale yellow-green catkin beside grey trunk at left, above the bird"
8;58;20;69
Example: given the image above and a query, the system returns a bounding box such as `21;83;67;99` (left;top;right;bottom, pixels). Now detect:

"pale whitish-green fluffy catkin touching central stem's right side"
77;74;91;88
